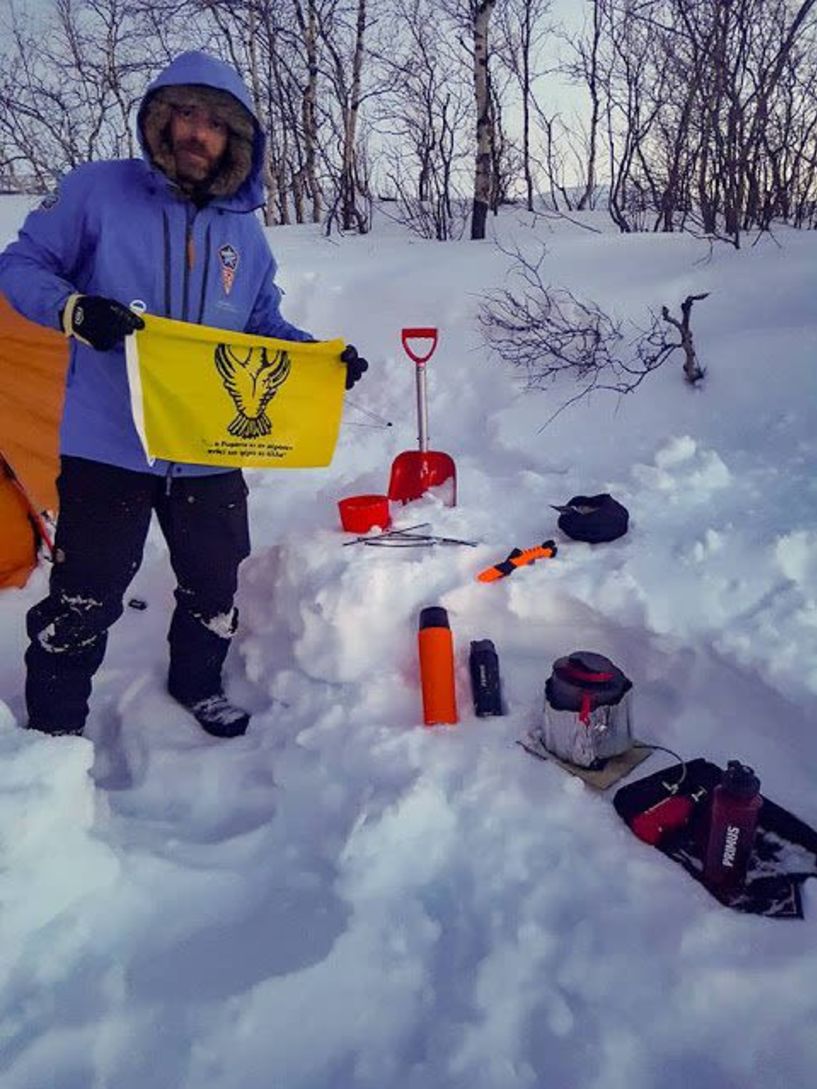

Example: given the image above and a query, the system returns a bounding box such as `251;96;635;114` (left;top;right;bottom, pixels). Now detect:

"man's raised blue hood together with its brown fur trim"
136;51;265;211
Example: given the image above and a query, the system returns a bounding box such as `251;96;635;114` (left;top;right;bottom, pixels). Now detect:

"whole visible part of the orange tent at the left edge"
0;295;68;588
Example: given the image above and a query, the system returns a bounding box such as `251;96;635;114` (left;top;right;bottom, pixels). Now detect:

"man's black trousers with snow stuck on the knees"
25;457;249;733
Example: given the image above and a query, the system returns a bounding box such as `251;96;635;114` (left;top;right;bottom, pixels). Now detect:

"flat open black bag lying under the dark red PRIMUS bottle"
613;757;817;919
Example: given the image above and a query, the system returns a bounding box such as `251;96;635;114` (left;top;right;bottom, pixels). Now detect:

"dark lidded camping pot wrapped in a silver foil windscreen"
540;650;633;768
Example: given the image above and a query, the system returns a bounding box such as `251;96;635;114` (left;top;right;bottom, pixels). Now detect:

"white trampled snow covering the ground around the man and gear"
0;199;817;1089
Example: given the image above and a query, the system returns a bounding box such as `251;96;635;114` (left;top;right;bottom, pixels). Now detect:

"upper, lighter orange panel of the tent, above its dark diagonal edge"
0;295;69;511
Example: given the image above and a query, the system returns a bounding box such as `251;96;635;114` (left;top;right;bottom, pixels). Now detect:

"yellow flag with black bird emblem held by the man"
125;315;345;468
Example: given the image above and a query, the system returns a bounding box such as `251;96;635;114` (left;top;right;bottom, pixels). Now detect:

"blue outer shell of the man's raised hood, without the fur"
136;50;266;211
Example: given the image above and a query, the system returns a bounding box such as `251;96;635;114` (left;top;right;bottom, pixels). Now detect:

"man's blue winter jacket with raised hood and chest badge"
0;52;312;475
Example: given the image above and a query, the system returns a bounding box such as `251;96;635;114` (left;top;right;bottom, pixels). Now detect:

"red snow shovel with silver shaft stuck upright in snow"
389;328;456;506
